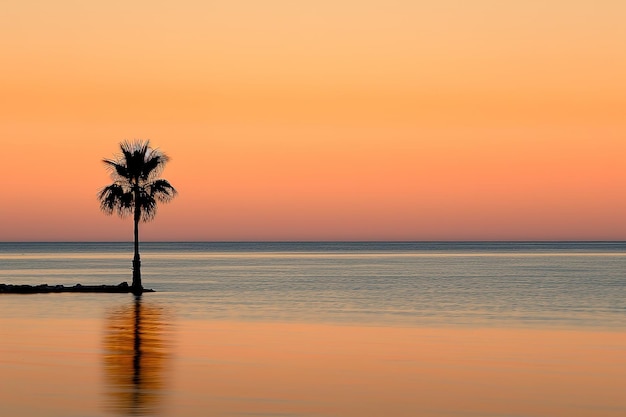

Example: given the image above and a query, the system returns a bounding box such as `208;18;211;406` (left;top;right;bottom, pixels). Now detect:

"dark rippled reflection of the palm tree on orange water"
103;296;172;416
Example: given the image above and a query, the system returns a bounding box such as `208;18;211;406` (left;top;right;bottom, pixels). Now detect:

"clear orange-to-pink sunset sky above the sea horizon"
0;0;626;241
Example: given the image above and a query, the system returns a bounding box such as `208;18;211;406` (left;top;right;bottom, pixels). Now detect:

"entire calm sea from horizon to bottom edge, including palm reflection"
0;242;626;416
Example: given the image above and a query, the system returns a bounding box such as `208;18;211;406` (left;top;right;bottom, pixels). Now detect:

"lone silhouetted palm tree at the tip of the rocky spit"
98;140;176;294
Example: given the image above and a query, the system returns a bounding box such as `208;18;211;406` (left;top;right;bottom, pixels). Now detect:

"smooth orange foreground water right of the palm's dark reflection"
173;321;626;417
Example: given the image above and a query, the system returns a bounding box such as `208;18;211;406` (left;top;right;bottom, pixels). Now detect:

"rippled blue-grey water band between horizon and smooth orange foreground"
0;242;626;329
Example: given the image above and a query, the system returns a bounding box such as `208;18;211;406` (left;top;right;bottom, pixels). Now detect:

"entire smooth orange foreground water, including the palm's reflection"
0;312;626;417
